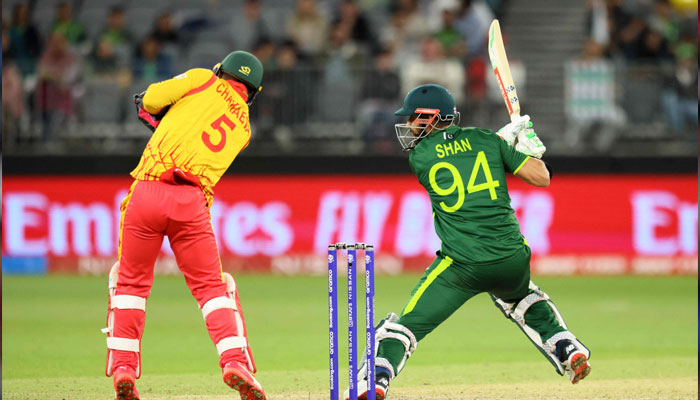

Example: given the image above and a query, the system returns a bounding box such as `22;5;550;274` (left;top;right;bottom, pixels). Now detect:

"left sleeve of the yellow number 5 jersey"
143;68;216;114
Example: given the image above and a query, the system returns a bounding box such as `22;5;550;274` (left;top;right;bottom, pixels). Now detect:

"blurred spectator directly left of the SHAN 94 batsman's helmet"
358;49;401;153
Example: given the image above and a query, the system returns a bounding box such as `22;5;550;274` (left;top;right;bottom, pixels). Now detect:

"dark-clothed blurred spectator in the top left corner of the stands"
3;3;41;76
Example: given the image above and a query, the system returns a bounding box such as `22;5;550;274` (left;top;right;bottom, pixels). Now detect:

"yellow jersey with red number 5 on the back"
131;68;250;205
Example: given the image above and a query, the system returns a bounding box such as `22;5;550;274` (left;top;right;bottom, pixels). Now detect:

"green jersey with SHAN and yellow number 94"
409;126;529;264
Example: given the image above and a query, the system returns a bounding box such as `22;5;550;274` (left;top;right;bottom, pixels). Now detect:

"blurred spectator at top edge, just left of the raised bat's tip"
455;0;494;57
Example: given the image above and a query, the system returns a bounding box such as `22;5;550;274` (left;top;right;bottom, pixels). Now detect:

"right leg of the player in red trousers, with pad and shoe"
168;207;265;400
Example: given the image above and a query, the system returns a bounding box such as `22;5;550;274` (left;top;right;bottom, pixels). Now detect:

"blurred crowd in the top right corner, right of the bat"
582;0;700;141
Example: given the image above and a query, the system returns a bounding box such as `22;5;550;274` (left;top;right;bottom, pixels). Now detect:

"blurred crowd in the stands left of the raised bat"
2;0;506;152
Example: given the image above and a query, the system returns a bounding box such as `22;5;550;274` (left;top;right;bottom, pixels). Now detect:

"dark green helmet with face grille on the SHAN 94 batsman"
394;83;459;151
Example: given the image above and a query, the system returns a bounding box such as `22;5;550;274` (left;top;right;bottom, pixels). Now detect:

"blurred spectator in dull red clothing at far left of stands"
36;31;81;140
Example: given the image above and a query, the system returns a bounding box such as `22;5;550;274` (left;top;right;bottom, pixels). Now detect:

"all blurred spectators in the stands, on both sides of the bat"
2;0;697;152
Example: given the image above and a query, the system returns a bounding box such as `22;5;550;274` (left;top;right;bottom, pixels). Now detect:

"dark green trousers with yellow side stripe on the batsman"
377;246;565;371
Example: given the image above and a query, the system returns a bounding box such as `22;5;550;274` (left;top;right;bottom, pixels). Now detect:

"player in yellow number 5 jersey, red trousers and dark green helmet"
103;51;265;400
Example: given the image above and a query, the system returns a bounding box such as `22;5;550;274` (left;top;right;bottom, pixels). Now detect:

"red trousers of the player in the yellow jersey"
114;181;246;369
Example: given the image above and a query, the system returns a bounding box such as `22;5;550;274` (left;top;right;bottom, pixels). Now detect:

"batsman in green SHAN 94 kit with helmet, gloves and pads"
345;84;591;399
